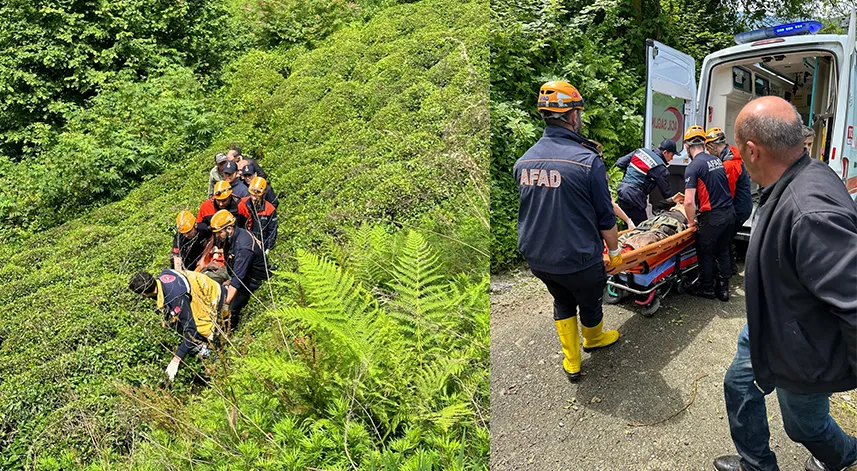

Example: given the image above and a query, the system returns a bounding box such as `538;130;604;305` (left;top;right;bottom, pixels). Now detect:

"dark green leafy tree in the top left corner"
0;0;240;160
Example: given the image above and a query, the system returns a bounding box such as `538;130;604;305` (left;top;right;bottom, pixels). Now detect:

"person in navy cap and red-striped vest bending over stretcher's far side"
616;139;676;225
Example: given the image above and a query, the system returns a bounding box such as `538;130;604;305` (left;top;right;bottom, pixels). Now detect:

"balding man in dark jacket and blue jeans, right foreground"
714;96;857;471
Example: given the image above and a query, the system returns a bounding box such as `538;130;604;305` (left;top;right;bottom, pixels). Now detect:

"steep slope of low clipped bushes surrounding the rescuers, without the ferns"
0;0;488;469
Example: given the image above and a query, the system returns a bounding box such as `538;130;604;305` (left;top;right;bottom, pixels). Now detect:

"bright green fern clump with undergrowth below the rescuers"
111;226;488;470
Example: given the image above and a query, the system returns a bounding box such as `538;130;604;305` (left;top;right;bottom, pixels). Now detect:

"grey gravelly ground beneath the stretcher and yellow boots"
491;271;857;471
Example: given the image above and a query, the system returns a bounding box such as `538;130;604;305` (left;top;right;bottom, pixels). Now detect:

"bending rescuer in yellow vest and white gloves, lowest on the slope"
128;269;224;381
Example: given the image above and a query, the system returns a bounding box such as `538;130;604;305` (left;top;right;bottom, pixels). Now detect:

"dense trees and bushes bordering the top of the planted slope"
0;0;438;238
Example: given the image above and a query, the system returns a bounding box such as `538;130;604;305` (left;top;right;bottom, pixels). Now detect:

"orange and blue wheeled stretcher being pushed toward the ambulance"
604;227;699;317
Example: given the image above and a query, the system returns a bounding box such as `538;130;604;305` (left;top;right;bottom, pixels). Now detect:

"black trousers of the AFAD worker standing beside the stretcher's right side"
696;206;735;291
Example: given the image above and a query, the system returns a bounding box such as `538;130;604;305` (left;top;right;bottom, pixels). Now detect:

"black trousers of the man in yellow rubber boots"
531;262;607;327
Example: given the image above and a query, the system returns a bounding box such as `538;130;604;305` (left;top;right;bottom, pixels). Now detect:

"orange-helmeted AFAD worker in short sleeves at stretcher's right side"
684;126;735;302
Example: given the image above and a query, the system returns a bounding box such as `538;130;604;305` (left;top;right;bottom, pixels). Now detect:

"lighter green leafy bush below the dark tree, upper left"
0;68;218;235
